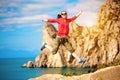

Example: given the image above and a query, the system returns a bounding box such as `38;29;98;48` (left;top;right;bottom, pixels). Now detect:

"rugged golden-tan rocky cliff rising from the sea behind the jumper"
23;0;120;67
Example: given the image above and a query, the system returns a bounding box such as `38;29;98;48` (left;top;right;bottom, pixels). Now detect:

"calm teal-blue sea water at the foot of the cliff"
0;58;94;80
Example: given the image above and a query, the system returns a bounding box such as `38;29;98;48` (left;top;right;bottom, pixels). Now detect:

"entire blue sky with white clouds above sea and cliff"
0;0;104;58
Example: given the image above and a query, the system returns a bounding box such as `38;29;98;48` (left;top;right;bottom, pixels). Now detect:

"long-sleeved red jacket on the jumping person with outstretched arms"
47;16;77;37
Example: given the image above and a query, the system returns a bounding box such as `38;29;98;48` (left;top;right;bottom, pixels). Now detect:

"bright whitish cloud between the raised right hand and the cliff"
67;0;103;26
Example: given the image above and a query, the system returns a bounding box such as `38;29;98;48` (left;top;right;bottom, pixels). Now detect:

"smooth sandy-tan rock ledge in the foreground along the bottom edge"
29;65;120;80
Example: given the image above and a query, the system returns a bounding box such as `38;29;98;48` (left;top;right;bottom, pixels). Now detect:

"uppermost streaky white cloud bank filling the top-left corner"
0;0;66;16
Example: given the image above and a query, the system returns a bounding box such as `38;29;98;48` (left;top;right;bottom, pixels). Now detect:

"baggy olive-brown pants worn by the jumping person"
52;37;75;54
